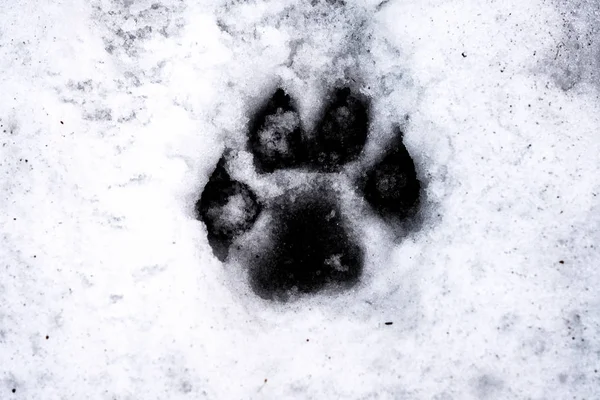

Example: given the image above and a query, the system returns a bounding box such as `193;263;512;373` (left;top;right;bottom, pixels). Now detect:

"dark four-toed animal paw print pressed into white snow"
196;87;421;300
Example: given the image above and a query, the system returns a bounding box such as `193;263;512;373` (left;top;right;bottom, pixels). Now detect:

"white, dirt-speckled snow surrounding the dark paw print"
0;0;600;400
